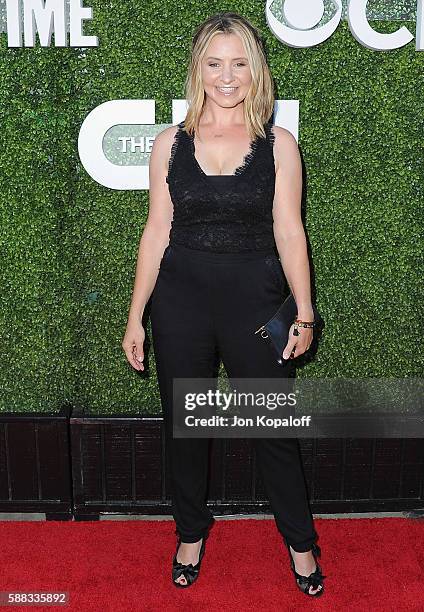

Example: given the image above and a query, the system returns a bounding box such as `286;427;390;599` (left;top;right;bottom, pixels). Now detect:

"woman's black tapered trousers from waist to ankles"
150;244;317;552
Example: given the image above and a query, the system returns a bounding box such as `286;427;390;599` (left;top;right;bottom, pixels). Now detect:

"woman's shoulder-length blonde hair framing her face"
184;12;275;140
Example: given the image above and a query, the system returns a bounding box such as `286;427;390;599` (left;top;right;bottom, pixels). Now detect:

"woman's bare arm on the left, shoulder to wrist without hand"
128;126;178;321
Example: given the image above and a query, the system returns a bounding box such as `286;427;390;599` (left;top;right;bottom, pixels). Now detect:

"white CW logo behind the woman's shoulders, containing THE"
78;100;299;190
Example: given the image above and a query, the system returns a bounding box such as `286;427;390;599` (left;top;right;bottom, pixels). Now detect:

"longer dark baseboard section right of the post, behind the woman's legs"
70;410;424;520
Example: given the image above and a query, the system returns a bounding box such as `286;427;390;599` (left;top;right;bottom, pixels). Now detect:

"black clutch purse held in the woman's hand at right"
254;292;324;365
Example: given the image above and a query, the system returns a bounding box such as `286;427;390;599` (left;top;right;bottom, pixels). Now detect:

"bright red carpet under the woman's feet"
0;518;424;612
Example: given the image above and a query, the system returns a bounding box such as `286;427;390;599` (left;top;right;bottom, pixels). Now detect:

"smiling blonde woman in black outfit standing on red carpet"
122;13;324;595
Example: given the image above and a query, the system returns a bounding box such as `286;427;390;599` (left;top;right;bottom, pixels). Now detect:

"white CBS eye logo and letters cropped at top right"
265;0;424;51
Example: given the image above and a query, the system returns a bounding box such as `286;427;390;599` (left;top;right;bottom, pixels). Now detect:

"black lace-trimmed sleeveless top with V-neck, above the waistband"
166;121;276;253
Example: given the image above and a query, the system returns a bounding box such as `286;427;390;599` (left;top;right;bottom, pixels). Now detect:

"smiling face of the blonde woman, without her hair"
202;34;252;107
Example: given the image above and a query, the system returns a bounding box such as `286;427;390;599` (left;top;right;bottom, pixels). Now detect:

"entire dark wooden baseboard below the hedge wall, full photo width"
0;407;424;520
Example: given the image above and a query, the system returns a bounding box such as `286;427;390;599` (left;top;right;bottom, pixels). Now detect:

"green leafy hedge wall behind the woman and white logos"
0;0;424;414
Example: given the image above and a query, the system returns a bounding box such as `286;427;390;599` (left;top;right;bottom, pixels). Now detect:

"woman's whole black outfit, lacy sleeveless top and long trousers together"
150;121;317;552
